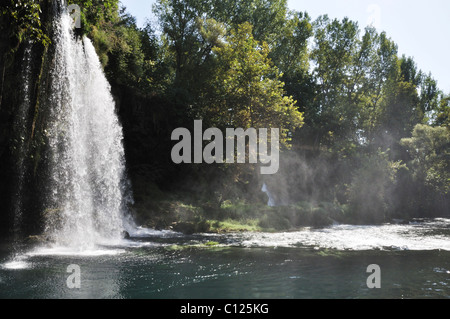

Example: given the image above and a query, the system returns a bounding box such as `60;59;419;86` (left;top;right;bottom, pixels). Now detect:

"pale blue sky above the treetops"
121;0;450;94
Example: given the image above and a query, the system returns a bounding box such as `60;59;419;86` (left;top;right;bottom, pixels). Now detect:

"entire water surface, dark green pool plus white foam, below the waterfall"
0;219;450;299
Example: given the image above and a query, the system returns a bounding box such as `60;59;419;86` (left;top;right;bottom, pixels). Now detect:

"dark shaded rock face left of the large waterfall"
0;0;55;238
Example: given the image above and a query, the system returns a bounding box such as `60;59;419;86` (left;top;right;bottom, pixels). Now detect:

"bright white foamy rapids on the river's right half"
237;219;450;251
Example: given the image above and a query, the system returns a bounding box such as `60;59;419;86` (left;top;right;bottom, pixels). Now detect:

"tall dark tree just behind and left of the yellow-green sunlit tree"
154;0;225;116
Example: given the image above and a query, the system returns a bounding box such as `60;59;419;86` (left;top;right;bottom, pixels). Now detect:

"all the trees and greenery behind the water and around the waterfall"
0;0;450;238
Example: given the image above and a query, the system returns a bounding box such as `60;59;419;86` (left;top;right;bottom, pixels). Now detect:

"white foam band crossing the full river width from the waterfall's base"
0;218;450;269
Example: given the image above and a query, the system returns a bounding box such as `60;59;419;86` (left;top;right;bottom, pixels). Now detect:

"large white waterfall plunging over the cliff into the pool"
44;6;130;249
